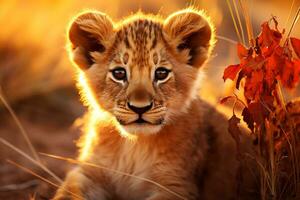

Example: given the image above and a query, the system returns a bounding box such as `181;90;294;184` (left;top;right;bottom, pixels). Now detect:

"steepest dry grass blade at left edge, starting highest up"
0;86;41;162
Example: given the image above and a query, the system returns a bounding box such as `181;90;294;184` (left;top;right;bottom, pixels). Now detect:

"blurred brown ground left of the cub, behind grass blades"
0;88;84;200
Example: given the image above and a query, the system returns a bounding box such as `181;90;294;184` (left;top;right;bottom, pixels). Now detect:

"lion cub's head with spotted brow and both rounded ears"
69;9;212;134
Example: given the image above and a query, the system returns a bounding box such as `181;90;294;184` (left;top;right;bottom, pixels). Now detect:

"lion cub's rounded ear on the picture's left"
68;12;115;69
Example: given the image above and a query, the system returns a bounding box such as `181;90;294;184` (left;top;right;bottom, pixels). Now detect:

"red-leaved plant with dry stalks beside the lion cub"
221;17;300;199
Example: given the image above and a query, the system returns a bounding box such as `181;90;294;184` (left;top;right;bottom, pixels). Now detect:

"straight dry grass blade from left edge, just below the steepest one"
0;137;62;183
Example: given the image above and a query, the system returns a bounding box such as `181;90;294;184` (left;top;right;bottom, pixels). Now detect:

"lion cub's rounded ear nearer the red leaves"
163;9;214;67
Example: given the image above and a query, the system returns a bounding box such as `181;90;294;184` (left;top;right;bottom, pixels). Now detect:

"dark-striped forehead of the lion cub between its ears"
115;19;163;66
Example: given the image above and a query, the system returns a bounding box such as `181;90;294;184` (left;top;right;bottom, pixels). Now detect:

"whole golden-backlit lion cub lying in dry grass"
54;8;256;200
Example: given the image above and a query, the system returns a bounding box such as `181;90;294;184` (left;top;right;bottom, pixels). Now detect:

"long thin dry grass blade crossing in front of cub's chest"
40;153;187;200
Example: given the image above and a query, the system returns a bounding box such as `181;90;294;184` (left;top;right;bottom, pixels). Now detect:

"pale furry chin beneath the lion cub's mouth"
121;123;162;135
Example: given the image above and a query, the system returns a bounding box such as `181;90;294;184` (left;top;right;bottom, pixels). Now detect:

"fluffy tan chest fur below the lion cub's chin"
88;133;158;200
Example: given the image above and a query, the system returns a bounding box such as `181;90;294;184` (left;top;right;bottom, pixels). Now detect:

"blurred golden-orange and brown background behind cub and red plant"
0;0;300;199
